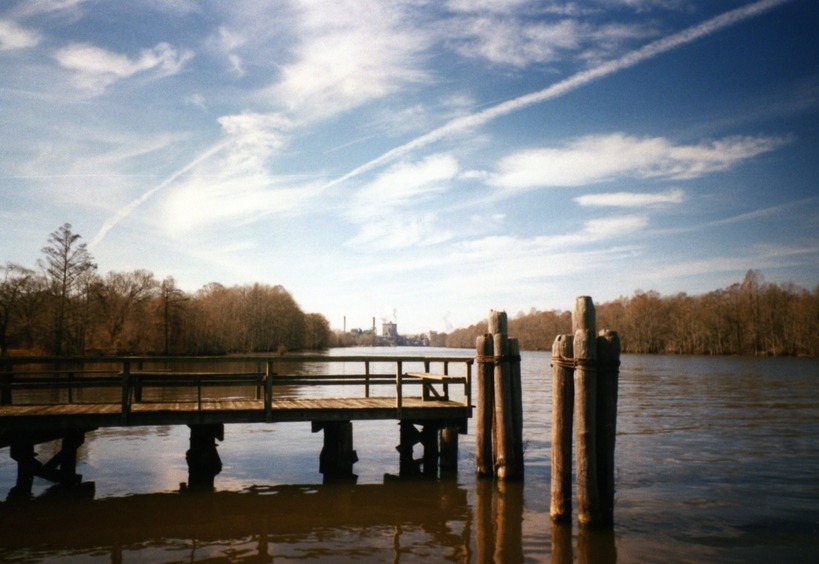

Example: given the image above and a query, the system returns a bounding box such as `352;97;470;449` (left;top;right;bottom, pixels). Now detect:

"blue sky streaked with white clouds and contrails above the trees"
0;0;819;334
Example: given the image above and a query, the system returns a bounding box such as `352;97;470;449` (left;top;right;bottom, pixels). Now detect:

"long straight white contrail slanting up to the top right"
324;0;792;188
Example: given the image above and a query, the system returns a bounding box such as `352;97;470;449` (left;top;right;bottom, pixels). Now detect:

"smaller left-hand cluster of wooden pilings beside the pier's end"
475;311;523;480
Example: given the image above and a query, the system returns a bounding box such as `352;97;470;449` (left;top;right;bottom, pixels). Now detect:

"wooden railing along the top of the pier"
0;355;474;422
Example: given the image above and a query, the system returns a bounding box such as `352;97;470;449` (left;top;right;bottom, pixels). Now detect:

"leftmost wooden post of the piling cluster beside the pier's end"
475;334;495;476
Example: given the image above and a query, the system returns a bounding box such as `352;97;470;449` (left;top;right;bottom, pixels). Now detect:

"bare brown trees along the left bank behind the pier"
0;223;332;355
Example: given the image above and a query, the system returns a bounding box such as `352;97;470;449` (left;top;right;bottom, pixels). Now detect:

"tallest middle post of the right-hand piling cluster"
572;296;600;525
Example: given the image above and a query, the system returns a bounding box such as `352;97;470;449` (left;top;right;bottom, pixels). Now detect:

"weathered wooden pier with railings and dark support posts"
0;355;473;496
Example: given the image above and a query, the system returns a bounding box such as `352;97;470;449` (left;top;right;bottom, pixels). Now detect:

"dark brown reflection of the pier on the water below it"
0;480;470;562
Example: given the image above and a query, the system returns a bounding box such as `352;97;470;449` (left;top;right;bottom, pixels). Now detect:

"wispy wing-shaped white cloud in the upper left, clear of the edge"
54;43;193;94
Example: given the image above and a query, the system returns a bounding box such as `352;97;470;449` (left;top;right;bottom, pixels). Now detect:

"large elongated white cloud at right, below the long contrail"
489;133;787;189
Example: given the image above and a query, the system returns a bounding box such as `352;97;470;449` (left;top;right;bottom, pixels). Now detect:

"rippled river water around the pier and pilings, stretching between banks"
0;348;819;563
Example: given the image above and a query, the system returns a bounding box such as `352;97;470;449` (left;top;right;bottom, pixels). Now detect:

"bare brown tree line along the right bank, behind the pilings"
445;270;819;356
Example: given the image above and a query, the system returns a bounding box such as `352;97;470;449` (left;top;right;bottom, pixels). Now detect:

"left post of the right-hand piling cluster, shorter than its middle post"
549;335;574;524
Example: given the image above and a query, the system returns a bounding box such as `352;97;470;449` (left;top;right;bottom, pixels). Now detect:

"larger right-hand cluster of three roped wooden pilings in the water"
550;296;620;526
